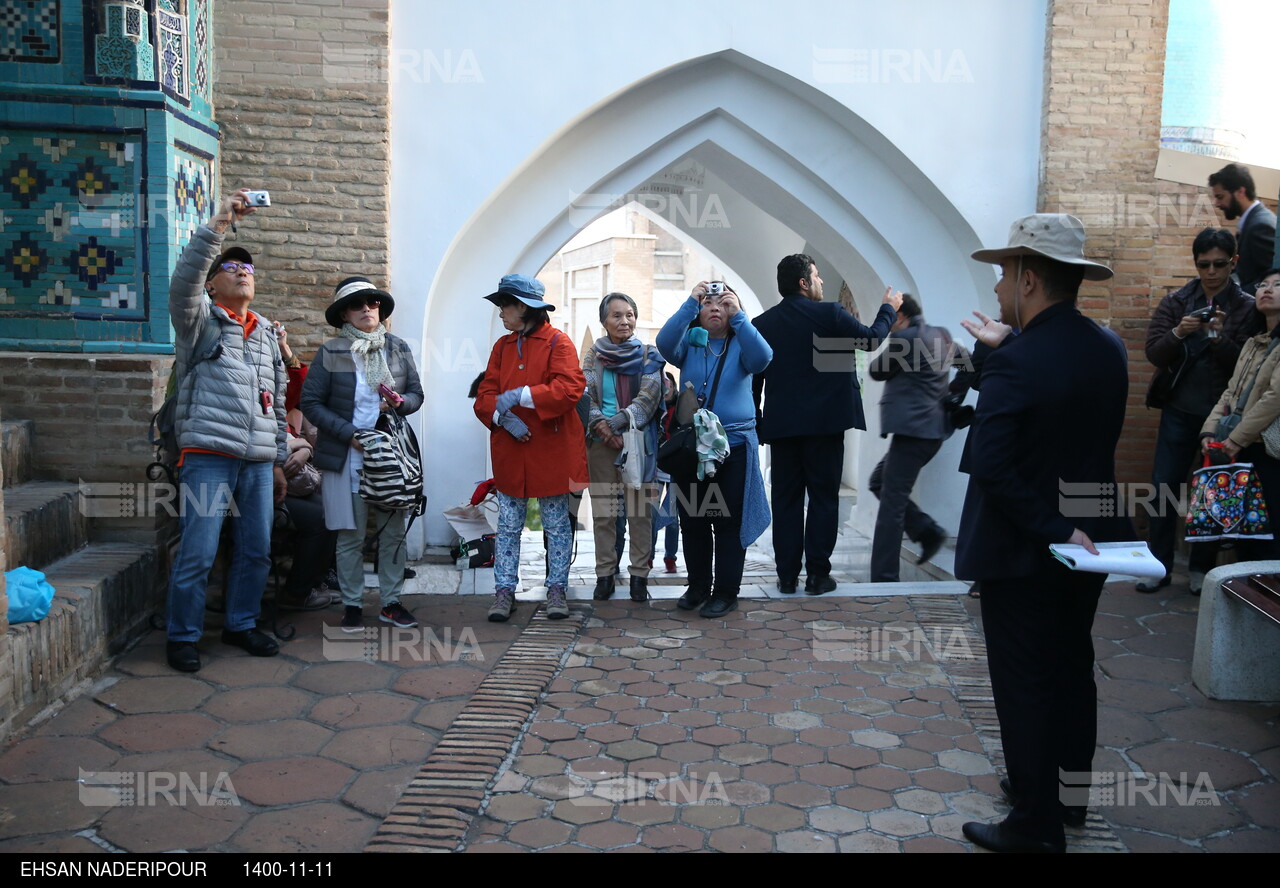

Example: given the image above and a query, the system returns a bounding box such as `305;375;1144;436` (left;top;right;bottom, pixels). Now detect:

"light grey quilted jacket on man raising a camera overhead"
169;225;288;464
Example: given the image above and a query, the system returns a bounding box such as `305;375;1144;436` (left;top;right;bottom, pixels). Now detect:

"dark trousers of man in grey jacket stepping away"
867;435;942;582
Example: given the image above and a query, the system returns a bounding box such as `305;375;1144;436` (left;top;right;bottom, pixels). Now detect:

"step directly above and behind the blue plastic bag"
4;481;88;571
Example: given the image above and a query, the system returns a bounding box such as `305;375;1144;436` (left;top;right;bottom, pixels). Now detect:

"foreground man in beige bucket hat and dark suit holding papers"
956;214;1133;852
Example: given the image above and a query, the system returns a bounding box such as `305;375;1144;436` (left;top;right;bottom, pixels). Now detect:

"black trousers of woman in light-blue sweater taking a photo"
672;444;748;599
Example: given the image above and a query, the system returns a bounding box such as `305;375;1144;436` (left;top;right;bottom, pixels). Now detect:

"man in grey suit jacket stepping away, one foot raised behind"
867;293;955;582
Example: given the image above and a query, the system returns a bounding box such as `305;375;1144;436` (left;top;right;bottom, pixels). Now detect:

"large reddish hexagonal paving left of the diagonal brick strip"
0;598;532;852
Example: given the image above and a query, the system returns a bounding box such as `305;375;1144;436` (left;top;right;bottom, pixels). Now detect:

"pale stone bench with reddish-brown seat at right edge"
1192;560;1280;702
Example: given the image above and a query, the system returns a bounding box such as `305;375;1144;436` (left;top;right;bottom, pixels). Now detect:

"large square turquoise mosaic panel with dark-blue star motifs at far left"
0;131;146;319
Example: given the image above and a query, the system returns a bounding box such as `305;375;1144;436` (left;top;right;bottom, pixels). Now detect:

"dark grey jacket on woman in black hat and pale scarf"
298;333;422;472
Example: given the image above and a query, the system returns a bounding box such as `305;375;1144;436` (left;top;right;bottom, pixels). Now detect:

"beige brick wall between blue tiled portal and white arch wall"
214;0;390;357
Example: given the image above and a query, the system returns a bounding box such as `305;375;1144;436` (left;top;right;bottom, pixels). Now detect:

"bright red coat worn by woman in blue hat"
475;324;588;498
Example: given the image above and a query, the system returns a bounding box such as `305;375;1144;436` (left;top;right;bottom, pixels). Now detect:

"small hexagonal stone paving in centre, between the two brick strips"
467;598;1120;852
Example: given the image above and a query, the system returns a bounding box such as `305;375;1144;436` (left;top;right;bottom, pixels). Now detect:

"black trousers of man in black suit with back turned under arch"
769;432;845;582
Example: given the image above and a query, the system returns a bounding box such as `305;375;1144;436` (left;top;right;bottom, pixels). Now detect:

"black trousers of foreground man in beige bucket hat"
980;562;1106;844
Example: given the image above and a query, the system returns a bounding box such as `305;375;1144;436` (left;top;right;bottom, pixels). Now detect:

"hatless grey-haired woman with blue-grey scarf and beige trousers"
582;293;663;601
